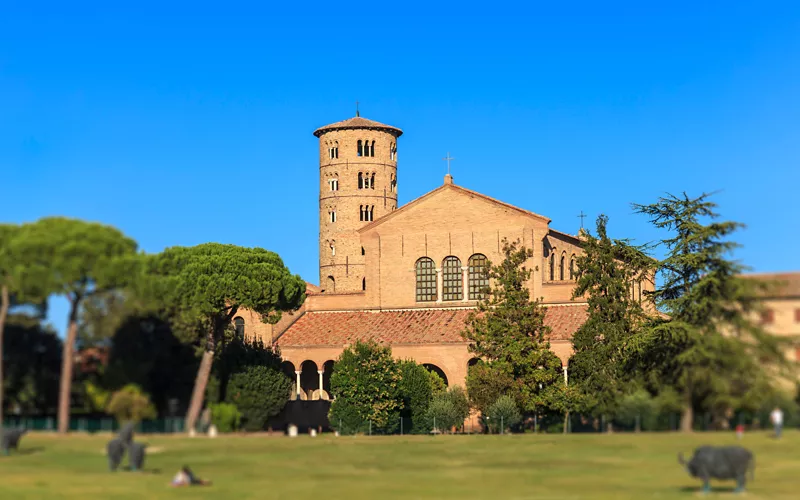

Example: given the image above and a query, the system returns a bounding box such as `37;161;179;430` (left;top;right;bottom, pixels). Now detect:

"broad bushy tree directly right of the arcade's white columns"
328;341;403;434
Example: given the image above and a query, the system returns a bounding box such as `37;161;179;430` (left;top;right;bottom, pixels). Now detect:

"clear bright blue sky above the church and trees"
0;0;800;331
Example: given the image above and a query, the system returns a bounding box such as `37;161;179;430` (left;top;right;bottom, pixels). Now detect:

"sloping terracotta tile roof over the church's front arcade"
278;305;587;346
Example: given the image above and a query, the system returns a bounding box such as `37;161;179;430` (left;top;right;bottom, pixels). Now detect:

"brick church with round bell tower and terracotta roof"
234;116;652;400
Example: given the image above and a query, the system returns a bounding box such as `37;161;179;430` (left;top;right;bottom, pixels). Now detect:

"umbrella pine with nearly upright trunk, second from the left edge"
14;217;137;433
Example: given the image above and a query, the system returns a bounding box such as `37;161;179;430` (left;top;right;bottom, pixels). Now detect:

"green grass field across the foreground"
0;431;800;500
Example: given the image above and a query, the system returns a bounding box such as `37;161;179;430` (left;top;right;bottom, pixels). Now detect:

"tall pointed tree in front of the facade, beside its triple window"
462;239;561;411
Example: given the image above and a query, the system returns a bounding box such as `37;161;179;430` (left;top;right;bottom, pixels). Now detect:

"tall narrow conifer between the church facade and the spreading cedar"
569;215;653;413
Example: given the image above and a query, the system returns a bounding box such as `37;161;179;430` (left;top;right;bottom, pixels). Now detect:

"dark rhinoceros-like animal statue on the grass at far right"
678;446;756;493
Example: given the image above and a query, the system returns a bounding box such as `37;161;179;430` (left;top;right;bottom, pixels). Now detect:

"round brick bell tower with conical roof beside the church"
314;114;403;293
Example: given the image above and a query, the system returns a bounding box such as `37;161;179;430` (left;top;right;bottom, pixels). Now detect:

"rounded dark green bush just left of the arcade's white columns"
226;366;292;431
